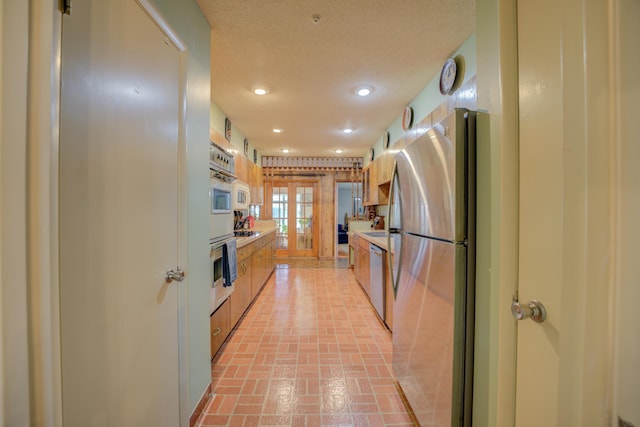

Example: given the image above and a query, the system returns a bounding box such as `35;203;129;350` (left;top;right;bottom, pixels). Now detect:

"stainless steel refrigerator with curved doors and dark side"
389;109;476;427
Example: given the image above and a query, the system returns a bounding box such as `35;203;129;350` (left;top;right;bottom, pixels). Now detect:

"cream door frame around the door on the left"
0;0;190;427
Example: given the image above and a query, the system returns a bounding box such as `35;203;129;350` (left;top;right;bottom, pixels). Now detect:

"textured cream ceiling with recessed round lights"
197;0;475;156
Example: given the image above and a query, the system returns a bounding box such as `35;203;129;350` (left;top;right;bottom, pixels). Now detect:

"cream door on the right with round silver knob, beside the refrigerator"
515;0;624;427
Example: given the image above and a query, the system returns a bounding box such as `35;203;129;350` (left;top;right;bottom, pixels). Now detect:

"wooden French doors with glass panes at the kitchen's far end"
271;181;319;257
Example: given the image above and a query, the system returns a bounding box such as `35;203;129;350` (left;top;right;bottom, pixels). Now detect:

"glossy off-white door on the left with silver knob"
60;0;180;427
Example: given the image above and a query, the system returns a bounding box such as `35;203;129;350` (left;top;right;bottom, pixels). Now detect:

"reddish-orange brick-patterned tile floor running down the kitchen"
197;264;414;427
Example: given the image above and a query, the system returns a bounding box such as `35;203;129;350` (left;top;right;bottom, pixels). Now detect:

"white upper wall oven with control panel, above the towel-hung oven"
209;143;236;244
